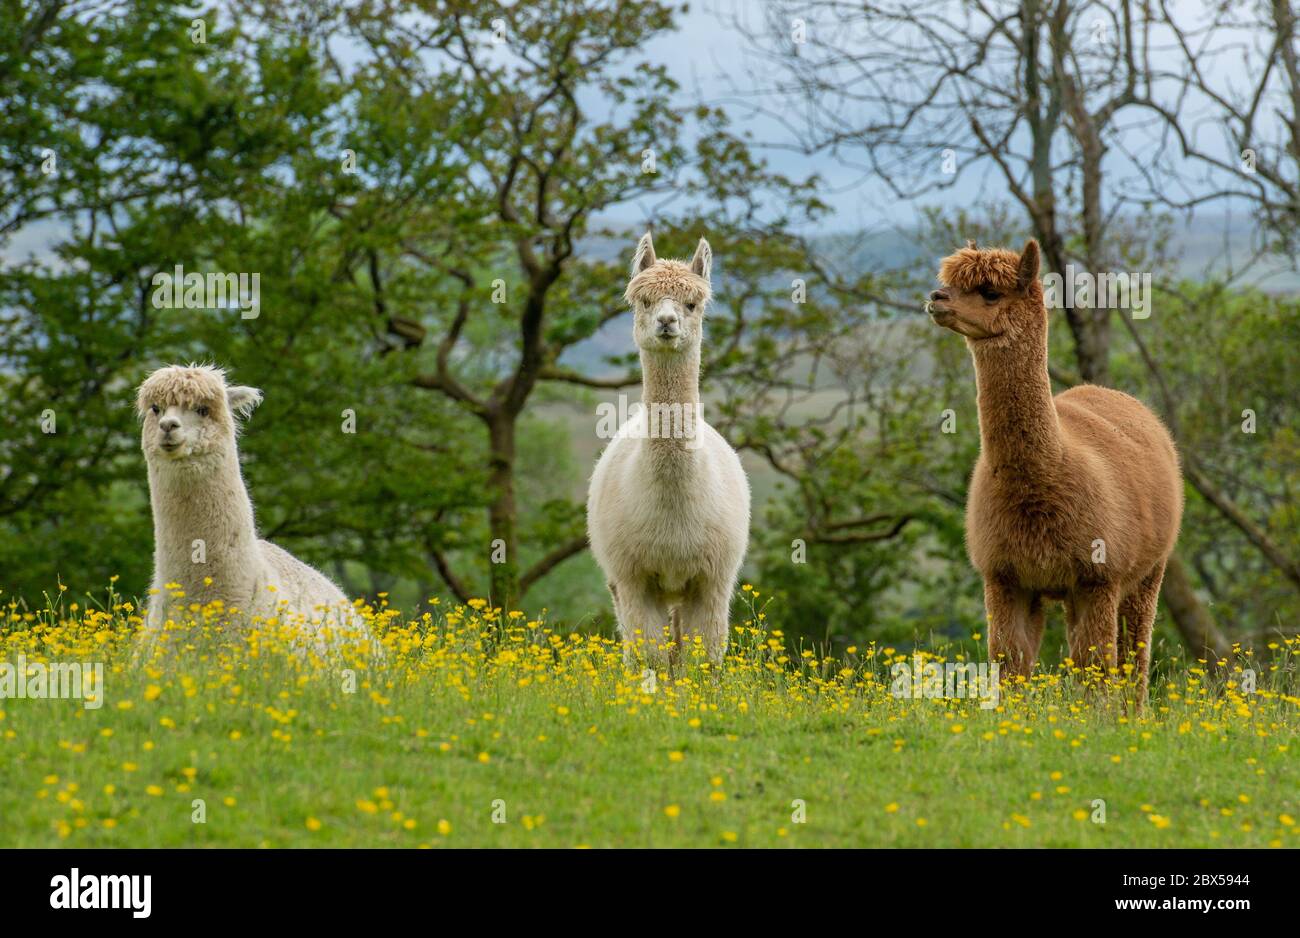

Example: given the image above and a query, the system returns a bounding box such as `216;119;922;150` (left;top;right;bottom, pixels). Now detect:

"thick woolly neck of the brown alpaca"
972;330;1062;478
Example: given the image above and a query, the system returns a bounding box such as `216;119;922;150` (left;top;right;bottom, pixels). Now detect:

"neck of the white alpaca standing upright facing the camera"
641;346;702;472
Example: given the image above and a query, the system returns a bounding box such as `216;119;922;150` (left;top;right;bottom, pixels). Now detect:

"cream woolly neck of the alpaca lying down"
150;447;257;584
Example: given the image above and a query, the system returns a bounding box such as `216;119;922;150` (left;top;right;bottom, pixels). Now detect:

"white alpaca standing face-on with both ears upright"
586;233;749;668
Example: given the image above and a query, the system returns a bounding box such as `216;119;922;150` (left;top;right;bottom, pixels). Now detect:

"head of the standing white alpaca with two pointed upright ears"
624;231;714;355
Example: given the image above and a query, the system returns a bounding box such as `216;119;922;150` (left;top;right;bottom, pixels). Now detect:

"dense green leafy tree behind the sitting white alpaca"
0;1;476;595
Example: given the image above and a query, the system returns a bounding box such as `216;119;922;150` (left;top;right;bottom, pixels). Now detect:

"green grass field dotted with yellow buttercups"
0;587;1300;847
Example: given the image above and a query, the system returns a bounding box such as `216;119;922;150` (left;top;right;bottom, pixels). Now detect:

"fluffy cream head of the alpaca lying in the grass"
135;365;261;466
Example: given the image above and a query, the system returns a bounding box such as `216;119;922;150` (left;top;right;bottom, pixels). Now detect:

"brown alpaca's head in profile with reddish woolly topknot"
926;238;1047;348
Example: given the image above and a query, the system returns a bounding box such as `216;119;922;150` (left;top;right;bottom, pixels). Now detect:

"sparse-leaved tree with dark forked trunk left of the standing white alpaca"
322;0;832;605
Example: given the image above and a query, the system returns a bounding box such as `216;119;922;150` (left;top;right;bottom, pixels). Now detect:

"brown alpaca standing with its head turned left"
927;240;1183;703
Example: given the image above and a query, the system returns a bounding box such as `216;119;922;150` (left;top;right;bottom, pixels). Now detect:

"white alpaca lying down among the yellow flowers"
137;365;367;651
